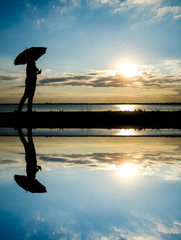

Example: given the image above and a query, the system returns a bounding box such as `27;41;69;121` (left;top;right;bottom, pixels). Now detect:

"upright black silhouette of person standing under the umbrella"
18;57;41;112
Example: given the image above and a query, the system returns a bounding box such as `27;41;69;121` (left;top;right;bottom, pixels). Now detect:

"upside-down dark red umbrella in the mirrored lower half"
14;175;47;193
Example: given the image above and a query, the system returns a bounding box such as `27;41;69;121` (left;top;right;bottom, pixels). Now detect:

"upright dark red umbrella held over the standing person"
14;47;47;65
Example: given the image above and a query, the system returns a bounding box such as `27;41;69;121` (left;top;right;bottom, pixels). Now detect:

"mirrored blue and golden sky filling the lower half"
0;137;181;240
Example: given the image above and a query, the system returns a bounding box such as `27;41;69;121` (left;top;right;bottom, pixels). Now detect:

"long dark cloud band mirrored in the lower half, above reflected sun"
39;151;181;168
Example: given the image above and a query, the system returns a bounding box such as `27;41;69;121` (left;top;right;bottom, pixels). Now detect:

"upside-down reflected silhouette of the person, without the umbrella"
18;129;41;182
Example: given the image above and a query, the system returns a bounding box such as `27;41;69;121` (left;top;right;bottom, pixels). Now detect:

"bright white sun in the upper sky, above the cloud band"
119;62;138;77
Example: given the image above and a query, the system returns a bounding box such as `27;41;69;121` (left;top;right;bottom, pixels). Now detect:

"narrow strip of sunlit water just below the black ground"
0;128;181;138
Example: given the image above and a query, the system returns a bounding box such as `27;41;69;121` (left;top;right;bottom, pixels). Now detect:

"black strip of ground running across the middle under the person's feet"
0;111;181;129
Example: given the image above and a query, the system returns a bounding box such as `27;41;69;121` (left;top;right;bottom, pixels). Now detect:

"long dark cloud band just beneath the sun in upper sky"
39;72;181;89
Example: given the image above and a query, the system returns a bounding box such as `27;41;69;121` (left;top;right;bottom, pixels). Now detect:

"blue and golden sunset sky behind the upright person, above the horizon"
0;0;181;103
